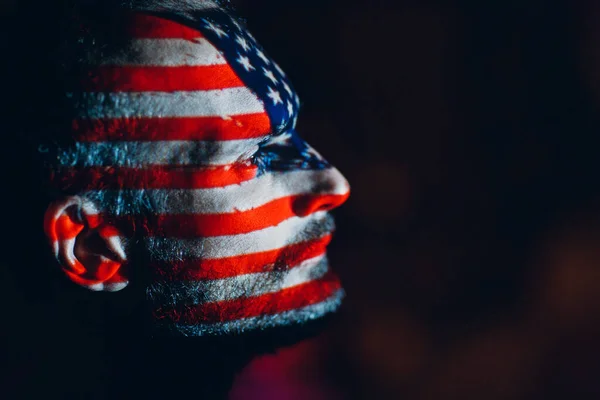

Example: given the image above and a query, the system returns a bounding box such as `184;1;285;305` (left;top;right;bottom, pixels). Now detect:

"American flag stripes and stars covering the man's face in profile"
46;2;349;336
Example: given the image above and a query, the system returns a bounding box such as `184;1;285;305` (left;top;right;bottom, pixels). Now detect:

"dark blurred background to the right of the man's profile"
0;0;600;400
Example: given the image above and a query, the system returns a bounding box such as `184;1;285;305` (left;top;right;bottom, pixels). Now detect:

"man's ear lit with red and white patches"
44;196;128;292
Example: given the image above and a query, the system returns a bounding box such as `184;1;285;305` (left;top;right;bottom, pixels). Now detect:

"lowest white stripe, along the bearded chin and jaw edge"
162;289;345;336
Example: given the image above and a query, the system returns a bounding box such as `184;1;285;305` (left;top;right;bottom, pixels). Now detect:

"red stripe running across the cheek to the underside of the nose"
137;195;347;238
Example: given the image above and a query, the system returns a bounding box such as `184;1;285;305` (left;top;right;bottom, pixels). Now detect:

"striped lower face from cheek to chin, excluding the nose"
142;176;343;335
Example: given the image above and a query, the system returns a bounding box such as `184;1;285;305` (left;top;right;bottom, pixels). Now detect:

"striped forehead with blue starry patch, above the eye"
71;10;299;140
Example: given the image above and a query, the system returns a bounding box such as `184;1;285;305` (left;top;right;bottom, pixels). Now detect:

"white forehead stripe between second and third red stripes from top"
68;87;265;118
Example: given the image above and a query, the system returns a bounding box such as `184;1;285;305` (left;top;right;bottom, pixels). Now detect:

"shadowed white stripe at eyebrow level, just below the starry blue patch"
58;138;263;168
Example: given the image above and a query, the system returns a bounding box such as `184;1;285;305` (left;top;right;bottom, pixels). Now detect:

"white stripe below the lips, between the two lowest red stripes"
146;256;329;306
